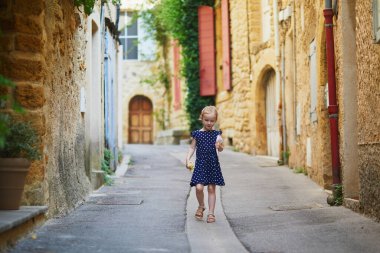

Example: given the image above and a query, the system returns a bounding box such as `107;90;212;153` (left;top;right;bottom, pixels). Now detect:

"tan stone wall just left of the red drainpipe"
282;1;332;188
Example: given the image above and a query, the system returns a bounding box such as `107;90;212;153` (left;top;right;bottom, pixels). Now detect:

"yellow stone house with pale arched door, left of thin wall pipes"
215;1;282;158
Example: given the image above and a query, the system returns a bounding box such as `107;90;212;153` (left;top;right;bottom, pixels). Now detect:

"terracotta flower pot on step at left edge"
0;158;30;210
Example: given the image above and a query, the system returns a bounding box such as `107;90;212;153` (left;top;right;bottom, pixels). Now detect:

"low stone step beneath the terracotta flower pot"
0;206;48;252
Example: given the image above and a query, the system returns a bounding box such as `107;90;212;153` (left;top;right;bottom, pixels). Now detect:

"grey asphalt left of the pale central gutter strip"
11;145;190;253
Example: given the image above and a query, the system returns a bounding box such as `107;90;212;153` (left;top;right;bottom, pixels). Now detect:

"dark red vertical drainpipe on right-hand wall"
323;0;341;185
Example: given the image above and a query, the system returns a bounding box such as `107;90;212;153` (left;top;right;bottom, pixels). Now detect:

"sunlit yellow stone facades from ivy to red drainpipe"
215;0;331;190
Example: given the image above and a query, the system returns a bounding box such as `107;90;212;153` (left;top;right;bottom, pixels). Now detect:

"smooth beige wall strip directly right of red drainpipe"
334;1;359;206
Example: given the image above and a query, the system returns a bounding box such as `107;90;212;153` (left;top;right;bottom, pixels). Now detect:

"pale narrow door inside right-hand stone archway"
263;69;280;157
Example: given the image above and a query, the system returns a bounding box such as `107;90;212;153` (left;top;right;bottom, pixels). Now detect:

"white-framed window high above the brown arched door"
119;12;138;60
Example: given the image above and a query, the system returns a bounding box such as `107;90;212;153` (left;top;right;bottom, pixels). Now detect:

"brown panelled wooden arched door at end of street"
128;96;153;144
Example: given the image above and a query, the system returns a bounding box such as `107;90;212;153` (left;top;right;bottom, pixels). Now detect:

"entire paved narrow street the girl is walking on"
10;145;380;253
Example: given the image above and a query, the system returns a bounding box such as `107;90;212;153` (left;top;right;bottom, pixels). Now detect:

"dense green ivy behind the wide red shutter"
156;0;215;131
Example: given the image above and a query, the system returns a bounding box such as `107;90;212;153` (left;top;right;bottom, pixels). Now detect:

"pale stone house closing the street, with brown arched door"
120;1;187;144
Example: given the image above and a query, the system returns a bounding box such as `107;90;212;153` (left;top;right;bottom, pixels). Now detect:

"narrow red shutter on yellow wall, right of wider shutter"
222;0;231;90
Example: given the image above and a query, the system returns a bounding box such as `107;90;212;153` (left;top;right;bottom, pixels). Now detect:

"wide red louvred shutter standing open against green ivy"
198;6;216;96
